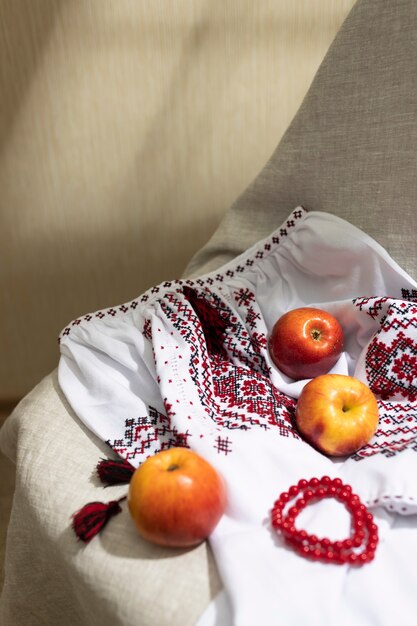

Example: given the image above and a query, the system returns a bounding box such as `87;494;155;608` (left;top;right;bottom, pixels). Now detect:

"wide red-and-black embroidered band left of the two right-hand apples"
161;282;298;438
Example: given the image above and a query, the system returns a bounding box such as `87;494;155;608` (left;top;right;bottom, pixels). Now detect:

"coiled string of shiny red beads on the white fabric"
271;476;378;565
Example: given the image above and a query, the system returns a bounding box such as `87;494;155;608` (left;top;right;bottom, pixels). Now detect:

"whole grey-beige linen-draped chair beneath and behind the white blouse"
0;0;417;626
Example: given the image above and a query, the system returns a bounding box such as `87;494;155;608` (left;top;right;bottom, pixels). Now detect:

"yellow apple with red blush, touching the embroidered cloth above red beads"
295;374;378;456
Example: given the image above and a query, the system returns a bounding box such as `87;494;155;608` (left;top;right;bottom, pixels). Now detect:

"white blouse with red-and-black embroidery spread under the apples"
59;207;417;626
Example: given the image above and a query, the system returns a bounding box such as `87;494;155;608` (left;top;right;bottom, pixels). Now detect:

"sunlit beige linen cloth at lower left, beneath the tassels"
0;371;220;626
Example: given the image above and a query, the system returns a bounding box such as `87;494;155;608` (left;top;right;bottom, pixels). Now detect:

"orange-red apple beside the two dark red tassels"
128;448;226;547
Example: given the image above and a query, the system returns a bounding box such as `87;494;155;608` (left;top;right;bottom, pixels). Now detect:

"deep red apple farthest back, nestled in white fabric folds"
269;307;344;380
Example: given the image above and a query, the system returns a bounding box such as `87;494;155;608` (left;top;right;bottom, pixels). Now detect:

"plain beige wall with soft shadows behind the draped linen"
0;0;354;400
